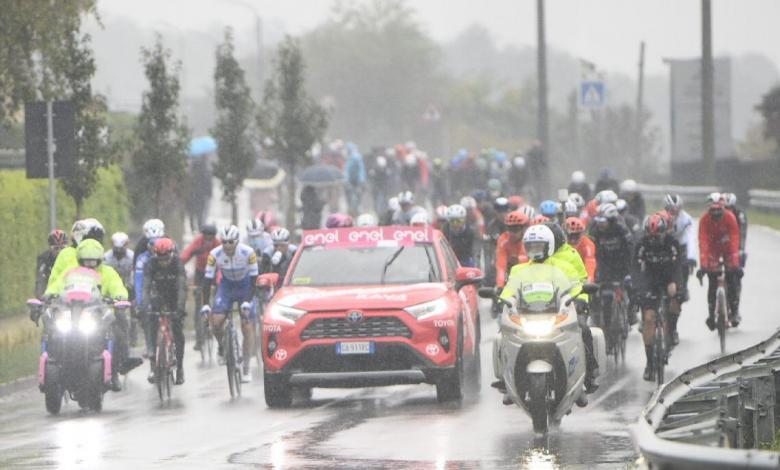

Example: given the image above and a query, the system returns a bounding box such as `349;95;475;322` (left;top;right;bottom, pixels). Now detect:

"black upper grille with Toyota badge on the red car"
301;317;412;341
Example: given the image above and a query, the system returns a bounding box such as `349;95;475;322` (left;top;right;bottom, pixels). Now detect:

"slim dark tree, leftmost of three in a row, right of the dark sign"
130;35;189;217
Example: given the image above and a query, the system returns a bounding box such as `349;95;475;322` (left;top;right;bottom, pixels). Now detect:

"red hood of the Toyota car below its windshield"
274;283;447;311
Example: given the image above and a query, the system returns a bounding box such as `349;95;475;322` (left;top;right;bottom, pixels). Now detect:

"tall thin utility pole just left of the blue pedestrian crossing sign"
536;0;552;190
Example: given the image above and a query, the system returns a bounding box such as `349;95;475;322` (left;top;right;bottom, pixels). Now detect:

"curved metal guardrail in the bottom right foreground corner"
631;330;780;469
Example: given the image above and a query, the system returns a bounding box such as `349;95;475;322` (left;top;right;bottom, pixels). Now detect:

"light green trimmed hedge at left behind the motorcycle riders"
0;166;129;316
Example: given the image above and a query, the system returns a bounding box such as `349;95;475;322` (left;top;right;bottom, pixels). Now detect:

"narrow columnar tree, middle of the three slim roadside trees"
212;28;255;224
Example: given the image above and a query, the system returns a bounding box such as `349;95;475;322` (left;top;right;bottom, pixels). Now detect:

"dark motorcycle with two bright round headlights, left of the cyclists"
27;267;130;414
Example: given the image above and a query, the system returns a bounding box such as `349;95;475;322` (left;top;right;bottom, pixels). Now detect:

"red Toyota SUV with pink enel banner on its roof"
258;226;482;407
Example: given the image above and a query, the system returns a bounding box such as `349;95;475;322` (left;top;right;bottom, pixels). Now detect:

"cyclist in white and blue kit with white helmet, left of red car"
203;225;258;380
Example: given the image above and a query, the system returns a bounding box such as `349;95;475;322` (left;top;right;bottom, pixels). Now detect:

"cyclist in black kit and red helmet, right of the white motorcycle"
634;214;681;381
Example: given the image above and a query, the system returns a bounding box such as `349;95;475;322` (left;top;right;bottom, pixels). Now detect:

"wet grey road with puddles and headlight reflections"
0;227;780;469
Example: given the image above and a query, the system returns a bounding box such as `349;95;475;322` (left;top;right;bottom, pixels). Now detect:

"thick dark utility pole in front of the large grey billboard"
701;0;716;183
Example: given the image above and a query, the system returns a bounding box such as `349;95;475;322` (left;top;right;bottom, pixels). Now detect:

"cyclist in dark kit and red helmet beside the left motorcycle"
142;238;187;385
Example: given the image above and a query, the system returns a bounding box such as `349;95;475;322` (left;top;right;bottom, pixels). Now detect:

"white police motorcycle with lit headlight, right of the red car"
479;266;606;434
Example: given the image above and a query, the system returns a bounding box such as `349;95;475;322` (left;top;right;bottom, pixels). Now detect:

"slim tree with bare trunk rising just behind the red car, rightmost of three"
257;36;328;228
